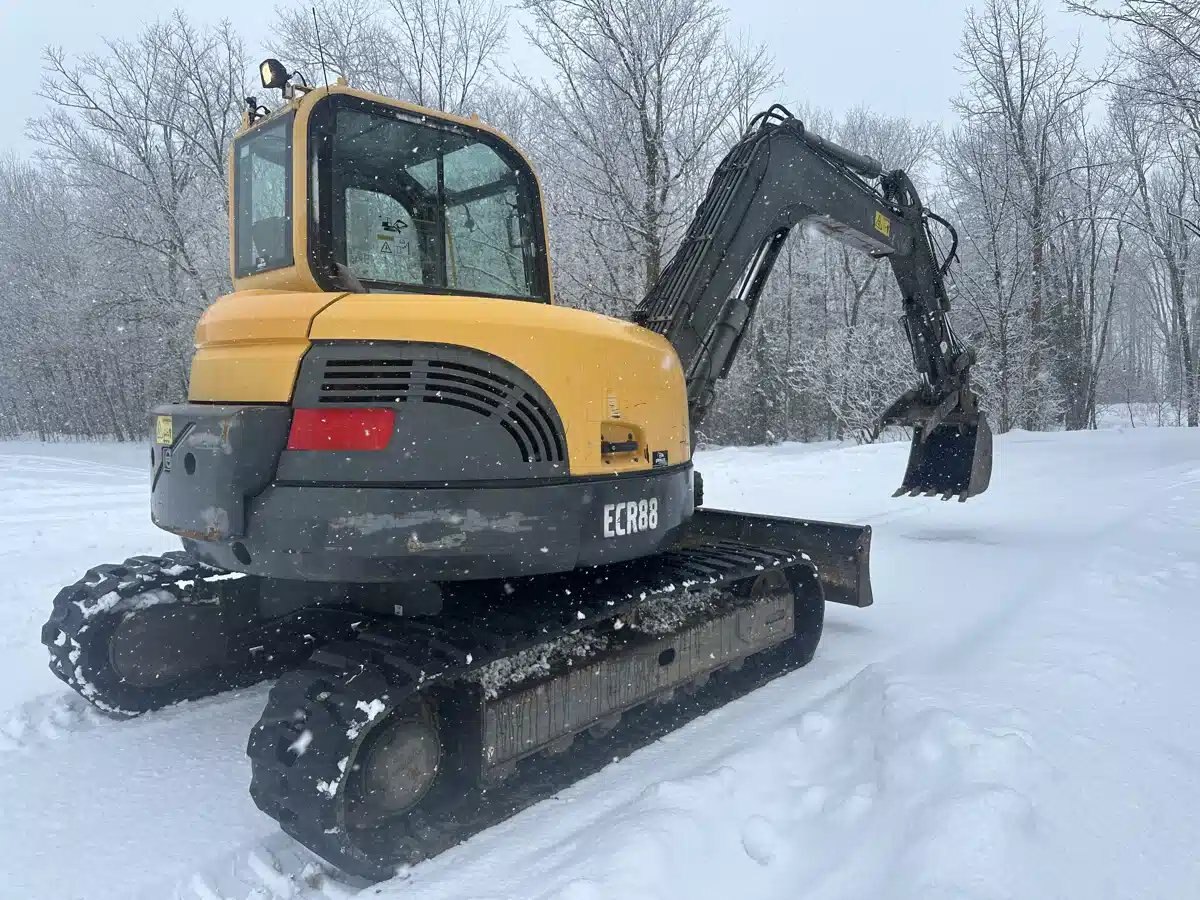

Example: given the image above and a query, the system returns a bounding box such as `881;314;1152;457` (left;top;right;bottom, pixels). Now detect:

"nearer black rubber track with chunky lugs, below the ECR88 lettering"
247;542;820;878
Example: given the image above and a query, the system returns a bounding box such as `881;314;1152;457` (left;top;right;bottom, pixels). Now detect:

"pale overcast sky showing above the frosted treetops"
0;0;1108;154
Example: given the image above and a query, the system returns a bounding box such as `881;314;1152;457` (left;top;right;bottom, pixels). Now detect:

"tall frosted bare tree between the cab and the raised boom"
516;0;778;310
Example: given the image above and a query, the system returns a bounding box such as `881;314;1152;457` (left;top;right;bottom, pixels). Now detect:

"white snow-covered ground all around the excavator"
0;427;1200;900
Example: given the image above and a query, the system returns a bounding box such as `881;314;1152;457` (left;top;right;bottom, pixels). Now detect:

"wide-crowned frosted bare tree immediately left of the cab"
29;13;246;317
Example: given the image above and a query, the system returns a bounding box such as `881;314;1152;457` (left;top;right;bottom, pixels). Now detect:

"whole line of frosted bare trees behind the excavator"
0;0;1200;444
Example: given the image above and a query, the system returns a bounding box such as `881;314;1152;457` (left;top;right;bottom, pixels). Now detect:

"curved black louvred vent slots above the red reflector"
319;358;566;462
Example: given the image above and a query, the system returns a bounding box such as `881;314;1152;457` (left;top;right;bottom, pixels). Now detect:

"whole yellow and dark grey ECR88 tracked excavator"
42;60;991;877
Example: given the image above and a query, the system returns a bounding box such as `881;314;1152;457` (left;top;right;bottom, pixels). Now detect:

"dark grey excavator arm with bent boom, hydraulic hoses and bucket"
632;106;991;500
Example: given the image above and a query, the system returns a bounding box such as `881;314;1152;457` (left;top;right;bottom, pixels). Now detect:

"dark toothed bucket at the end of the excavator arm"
894;413;991;502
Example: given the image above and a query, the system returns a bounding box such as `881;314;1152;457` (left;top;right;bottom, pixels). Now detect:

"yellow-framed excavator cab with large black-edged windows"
232;89;551;302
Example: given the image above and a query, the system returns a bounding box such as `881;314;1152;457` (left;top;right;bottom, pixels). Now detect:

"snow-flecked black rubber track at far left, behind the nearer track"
42;551;260;718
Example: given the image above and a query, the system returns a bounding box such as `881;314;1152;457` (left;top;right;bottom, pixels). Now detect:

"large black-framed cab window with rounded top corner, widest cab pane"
314;95;548;299
